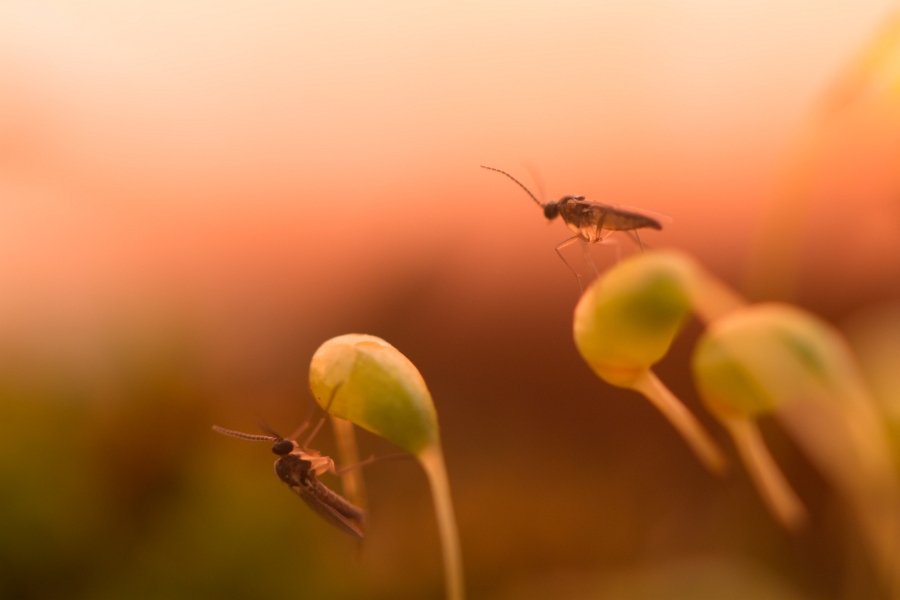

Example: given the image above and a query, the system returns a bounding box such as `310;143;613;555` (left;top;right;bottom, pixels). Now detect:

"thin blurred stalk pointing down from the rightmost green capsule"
722;419;807;531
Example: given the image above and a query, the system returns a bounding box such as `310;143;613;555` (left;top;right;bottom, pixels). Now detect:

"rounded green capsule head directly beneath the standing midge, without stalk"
573;252;696;387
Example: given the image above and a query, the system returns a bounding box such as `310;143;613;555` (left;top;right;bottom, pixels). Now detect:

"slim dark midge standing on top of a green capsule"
481;165;662;291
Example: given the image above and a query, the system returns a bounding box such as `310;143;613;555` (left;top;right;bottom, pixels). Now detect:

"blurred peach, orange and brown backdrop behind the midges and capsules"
0;0;900;600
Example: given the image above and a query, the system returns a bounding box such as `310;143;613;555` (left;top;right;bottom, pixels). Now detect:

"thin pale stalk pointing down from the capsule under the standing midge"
631;369;728;475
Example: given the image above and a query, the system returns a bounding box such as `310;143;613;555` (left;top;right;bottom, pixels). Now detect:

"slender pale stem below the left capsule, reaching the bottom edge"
418;443;466;600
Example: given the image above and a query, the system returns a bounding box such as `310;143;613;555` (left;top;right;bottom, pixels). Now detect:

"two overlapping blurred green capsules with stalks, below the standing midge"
574;251;900;590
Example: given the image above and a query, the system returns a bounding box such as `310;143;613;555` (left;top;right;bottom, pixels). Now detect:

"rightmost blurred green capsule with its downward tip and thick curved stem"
692;303;900;576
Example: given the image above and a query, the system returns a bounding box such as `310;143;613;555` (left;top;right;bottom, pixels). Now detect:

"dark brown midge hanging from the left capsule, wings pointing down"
213;388;374;539
